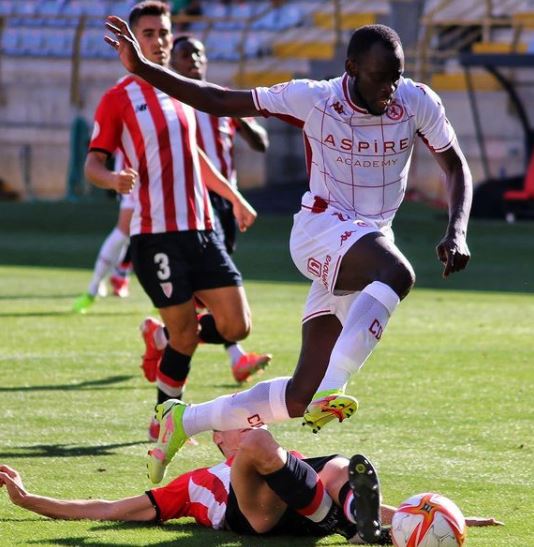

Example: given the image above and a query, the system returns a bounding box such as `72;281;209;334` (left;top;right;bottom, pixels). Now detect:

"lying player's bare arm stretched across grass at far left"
0;465;156;522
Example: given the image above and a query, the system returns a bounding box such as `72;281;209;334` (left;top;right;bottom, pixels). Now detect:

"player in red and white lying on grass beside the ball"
0;429;501;544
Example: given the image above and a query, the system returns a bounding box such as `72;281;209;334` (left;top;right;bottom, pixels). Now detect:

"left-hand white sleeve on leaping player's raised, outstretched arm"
252;80;328;124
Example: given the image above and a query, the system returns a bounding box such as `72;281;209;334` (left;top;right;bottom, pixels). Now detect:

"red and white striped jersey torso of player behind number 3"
195;110;237;187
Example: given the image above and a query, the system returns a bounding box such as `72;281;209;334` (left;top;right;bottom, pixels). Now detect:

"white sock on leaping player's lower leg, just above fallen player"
183;377;290;437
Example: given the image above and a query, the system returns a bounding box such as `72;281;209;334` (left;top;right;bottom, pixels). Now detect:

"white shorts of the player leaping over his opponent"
289;194;381;294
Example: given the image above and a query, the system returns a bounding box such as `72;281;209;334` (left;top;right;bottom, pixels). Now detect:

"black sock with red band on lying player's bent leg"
263;453;333;523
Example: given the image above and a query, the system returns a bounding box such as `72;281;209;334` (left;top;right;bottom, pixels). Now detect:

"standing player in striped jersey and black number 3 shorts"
86;1;262;436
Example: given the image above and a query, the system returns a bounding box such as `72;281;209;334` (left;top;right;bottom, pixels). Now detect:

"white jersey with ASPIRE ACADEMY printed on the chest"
253;74;456;227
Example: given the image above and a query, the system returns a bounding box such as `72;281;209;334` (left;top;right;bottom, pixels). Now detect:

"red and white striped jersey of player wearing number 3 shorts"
89;76;213;235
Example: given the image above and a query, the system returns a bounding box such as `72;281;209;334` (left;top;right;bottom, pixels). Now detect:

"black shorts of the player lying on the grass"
224;454;339;537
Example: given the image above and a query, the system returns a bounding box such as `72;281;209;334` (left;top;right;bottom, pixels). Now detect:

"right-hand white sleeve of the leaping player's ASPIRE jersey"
414;84;456;152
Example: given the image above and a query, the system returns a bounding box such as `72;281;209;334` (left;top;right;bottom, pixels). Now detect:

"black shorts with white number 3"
130;230;243;308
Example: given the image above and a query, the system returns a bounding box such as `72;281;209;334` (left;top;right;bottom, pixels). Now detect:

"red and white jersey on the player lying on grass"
150;459;231;529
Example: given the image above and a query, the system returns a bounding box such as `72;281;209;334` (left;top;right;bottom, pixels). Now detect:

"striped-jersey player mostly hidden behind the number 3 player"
137;35;271;390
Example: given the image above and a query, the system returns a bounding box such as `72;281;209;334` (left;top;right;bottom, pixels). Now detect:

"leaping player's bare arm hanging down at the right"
434;143;473;278
